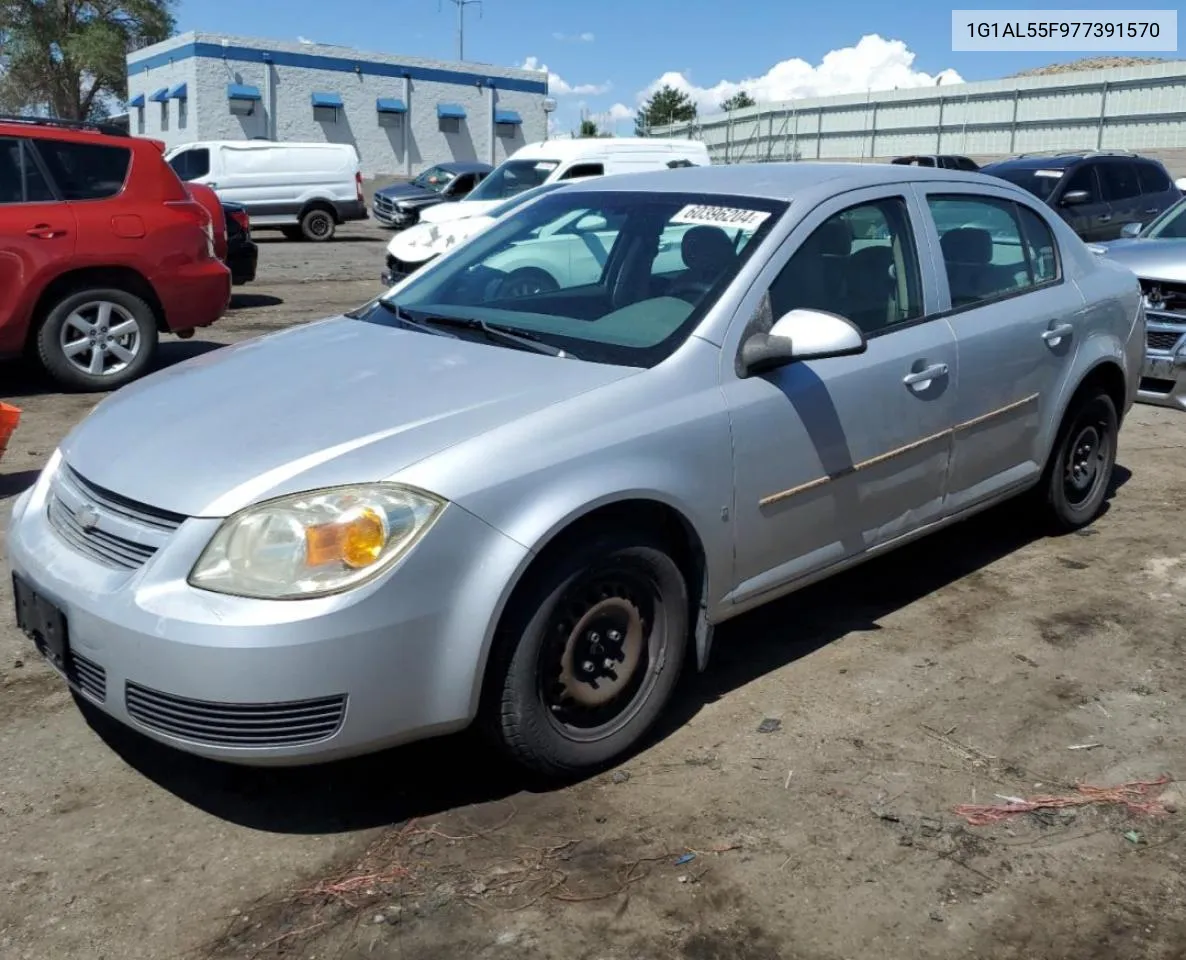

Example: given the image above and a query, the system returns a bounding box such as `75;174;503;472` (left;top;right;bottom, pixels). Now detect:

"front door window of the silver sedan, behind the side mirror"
770;197;923;335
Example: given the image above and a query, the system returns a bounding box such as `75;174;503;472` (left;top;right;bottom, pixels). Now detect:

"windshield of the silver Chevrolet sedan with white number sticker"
359;189;788;367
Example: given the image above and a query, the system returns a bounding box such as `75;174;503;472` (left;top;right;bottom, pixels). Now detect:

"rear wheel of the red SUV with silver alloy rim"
36;287;158;393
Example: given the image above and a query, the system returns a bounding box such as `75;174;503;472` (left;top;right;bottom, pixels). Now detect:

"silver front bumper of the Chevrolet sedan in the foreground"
8;462;527;765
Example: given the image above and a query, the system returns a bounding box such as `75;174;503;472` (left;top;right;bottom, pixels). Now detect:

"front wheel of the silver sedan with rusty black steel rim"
487;533;689;776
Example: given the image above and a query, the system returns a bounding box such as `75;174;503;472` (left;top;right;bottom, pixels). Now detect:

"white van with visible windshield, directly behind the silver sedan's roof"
420;136;710;223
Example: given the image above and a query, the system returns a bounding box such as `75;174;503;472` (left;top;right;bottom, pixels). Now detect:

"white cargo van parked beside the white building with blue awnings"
165;140;366;240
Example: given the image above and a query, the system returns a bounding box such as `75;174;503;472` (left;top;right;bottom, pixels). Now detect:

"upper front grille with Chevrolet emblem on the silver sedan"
46;465;185;570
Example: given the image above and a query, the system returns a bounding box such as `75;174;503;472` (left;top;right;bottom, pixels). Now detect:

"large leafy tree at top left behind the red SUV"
0;0;176;120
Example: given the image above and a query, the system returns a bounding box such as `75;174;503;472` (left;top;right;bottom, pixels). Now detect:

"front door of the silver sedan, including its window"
722;189;958;604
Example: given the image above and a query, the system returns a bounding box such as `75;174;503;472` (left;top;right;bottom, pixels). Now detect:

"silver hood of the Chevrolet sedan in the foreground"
62;317;639;517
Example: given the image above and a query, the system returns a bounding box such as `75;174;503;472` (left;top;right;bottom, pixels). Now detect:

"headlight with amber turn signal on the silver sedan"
189;483;445;599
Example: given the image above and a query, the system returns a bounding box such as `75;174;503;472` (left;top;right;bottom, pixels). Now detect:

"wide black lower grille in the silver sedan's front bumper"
125;681;346;748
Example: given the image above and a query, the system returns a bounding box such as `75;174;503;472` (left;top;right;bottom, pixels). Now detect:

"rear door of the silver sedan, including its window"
920;184;1084;513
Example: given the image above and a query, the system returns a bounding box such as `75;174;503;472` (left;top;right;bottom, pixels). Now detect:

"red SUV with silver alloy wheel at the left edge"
0;117;230;390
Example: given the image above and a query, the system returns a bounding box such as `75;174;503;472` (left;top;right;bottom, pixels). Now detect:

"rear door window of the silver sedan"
927;196;1053;310
